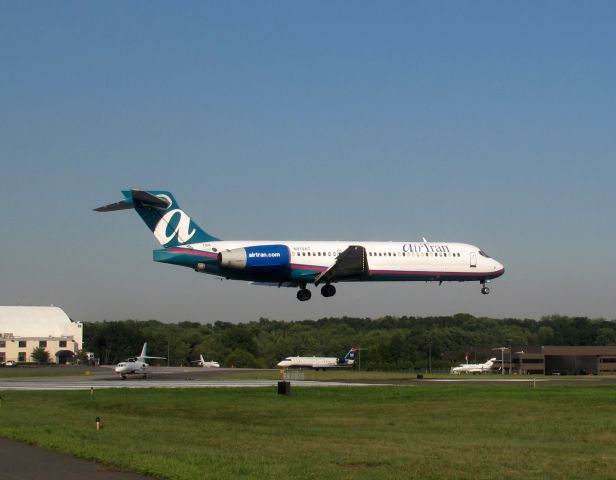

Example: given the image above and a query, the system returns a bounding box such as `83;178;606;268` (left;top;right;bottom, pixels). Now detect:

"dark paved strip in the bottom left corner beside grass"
0;438;154;480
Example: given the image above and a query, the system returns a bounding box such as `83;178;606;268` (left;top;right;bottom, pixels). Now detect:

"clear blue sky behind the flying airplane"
0;1;616;322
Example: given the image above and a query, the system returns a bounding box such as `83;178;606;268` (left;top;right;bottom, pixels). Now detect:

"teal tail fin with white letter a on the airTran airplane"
94;190;219;247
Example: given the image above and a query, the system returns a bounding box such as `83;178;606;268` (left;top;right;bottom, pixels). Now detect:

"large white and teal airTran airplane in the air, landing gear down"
94;190;505;302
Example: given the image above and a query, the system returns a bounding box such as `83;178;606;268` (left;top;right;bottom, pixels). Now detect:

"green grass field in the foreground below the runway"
0;384;616;479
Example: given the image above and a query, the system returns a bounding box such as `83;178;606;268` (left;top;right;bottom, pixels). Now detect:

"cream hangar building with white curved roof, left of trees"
0;306;83;364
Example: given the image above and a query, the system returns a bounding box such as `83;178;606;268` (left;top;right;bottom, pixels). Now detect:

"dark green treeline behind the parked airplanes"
84;314;616;369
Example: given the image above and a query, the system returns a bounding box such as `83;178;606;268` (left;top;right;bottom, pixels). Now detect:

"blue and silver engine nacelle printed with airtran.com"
218;245;290;271
